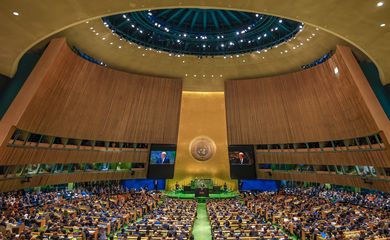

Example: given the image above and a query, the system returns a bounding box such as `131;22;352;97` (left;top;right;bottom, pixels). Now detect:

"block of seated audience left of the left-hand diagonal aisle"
0;185;160;239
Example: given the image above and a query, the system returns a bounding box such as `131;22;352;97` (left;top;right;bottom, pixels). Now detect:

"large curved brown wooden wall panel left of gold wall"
11;39;182;144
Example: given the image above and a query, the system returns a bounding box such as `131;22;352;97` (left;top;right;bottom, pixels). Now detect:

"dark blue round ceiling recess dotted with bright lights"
103;8;303;56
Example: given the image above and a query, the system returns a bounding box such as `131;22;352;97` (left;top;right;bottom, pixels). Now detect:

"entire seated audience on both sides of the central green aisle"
0;184;390;240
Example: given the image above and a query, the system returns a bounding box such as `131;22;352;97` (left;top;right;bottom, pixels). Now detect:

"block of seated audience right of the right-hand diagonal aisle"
244;188;390;239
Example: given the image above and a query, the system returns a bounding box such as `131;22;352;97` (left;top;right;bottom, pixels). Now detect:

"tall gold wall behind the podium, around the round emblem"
167;92;237;189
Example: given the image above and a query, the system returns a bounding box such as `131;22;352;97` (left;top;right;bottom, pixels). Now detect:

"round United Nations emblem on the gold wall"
190;136;216;161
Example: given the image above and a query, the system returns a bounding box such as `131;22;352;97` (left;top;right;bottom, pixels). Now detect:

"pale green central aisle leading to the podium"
192;203;211;240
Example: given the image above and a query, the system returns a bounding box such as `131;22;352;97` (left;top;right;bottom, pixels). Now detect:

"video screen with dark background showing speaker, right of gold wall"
229;145;256;179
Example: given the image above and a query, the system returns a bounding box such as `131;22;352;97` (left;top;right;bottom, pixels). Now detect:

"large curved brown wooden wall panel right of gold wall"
225;46;379;144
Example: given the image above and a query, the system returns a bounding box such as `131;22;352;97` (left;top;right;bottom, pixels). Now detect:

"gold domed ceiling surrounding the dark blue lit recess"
0;0;390;91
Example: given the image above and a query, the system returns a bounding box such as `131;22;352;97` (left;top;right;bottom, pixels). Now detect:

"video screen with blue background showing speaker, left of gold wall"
148;144;176;179
